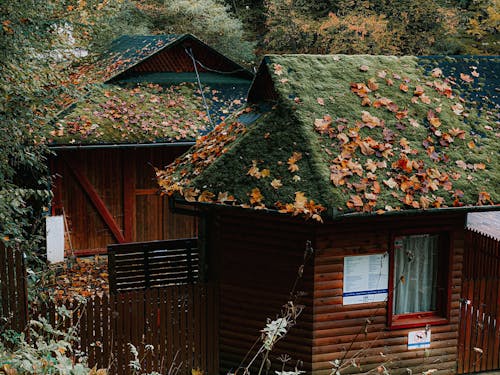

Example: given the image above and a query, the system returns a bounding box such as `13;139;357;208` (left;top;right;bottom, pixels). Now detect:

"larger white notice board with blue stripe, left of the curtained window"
342;253;389;305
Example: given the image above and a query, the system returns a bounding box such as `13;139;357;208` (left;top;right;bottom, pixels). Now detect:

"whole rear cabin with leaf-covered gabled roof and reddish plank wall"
49;34;253;255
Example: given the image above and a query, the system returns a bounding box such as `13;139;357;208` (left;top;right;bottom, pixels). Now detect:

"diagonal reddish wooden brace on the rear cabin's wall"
63;157;126;243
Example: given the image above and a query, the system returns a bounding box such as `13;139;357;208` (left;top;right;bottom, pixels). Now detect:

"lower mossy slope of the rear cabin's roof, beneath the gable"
48;83;246;145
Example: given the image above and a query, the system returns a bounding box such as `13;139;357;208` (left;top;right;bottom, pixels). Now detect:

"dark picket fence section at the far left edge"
0;243;28;332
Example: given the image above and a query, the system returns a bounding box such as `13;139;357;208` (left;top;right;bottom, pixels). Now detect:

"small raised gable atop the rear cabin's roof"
98;34;253;82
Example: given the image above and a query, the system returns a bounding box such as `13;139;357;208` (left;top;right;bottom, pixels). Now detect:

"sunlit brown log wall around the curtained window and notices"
312;214;465;375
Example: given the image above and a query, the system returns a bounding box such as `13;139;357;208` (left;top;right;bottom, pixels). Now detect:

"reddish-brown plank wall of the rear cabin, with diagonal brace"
51;147;197;255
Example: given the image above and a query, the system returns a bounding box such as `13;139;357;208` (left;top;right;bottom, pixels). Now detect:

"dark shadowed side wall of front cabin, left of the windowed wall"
212;211;313;374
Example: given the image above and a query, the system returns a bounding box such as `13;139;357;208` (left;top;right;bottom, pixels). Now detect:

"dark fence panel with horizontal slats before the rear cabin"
108;238;199;293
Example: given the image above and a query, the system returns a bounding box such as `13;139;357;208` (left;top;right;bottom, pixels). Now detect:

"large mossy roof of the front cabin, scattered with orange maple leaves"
157;55;500;220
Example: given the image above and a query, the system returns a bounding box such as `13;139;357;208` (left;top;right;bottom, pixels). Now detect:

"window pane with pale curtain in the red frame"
393;234;438;314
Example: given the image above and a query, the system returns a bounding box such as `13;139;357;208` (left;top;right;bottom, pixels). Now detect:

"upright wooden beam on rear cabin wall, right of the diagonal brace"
122;150;136;242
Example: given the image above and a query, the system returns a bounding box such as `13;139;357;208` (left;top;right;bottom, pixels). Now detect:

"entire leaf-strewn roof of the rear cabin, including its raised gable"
47;34;253;145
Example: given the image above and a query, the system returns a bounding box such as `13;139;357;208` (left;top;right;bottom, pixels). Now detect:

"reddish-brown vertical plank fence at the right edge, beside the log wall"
457;231;500;374
